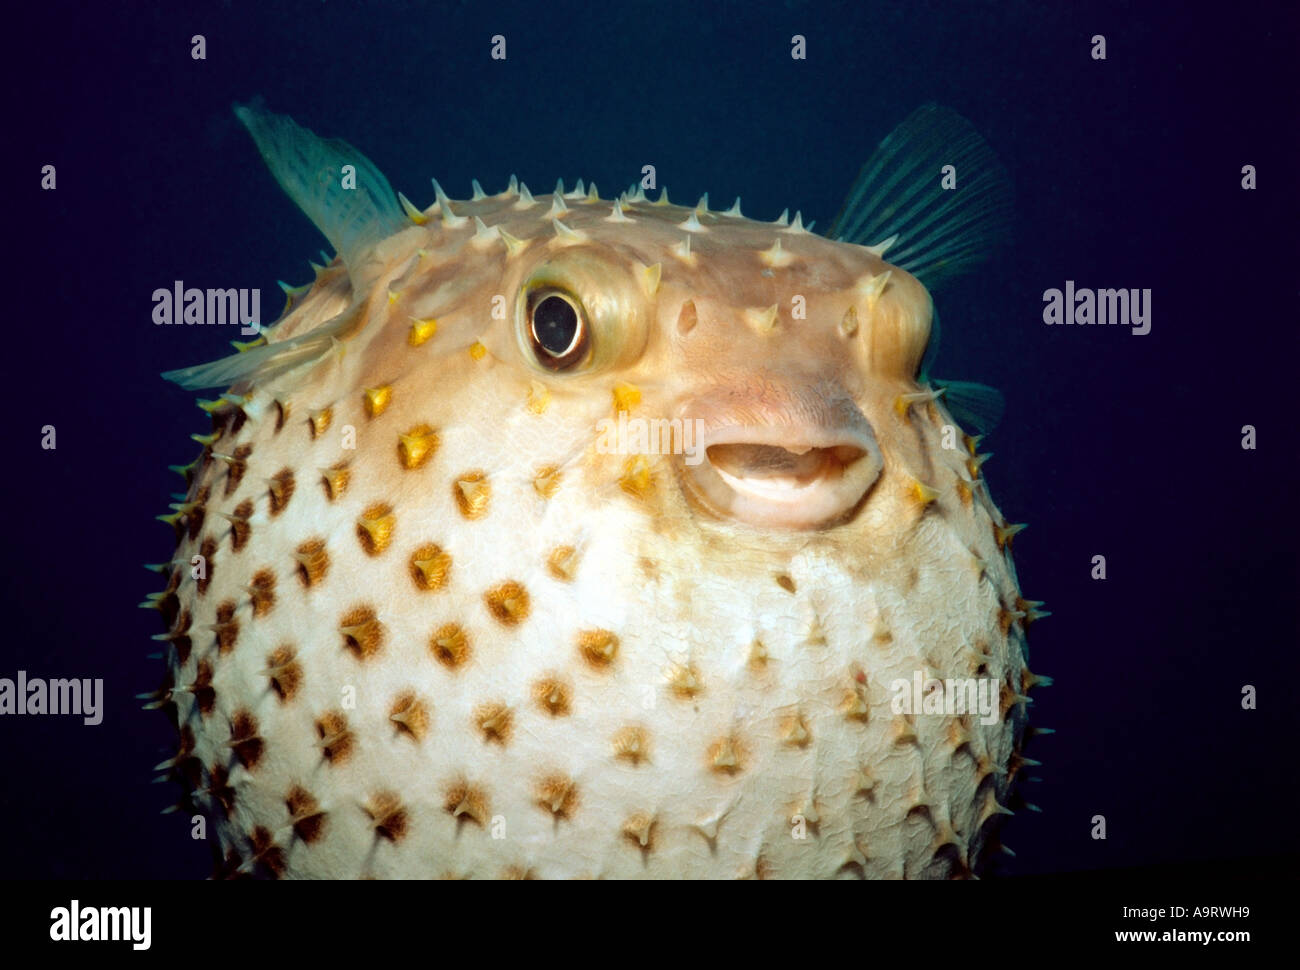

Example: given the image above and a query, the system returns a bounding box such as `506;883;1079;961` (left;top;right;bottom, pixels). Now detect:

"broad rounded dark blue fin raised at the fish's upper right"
827;104;1011;287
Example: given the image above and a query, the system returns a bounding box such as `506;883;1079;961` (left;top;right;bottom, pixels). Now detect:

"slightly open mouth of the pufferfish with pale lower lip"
684;408;883;529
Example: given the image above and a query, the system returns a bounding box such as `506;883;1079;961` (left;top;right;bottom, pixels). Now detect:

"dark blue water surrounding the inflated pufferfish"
0;0;1300;878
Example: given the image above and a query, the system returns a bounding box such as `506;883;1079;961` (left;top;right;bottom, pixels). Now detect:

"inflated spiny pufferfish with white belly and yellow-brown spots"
146;104;1045;879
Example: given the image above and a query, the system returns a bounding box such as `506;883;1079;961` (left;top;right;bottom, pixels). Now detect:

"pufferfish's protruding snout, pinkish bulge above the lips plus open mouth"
681;389;884;529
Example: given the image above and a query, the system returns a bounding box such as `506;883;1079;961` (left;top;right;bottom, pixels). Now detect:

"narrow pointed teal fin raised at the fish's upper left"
234;98;411;276
